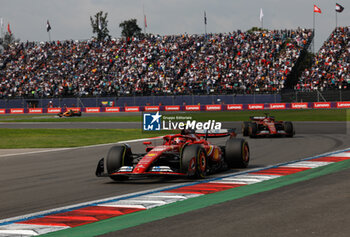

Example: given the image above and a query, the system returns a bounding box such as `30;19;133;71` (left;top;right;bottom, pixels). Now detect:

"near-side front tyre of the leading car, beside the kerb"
180;144;208;178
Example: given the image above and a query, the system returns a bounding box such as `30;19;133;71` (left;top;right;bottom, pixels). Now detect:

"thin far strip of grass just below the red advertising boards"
0;109;350;122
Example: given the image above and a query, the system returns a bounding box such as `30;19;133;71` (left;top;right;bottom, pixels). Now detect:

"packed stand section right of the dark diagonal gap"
295;27;350;91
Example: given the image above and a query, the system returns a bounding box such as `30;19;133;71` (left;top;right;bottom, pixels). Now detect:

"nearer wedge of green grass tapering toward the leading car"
0;128;169;149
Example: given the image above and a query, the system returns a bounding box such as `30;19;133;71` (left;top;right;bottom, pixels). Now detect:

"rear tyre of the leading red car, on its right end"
225;138;250;168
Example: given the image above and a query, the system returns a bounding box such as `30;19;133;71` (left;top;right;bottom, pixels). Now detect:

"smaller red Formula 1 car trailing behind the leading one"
242;114;295;138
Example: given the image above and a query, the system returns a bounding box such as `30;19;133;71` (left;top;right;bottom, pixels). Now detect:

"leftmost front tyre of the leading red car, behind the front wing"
106;144;132;181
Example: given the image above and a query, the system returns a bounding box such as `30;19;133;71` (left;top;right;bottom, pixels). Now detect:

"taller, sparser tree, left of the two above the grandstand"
90;11;111;41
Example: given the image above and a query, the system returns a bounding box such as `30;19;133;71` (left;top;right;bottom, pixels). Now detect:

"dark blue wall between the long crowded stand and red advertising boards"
0;94;281;109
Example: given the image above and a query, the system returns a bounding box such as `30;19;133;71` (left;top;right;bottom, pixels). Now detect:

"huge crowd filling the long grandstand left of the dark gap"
0;29;312;98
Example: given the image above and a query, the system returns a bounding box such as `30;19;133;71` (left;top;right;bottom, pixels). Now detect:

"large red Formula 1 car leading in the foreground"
96;130;250;181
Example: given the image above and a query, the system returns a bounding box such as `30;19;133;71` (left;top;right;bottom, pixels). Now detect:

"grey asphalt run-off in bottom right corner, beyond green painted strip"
102;163;350;237
